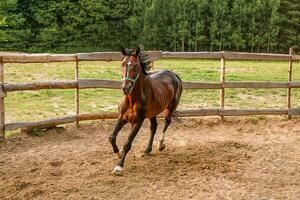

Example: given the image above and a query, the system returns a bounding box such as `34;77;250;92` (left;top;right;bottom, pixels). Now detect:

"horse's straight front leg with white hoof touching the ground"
113;119;144;175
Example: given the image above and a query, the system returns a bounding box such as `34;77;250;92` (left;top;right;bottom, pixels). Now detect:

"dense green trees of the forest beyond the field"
0;0;300;53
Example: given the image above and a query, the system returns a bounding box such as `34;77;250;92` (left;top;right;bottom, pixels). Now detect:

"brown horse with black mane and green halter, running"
109;47;182;175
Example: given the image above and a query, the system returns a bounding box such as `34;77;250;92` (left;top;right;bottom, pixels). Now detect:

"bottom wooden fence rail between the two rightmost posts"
219;109;288;116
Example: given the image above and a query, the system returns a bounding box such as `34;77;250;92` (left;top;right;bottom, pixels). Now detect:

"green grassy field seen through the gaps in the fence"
5;59;300;122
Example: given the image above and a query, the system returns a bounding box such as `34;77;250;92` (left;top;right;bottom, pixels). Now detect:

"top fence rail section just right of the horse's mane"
162;51;222;60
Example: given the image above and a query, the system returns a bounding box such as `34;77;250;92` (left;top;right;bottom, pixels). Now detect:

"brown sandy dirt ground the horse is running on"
0;117;300;200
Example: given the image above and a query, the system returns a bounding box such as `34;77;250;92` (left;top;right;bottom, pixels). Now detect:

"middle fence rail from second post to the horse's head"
78;79;122;89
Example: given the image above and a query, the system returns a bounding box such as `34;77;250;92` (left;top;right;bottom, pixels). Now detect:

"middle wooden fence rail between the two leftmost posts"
3;81;77;92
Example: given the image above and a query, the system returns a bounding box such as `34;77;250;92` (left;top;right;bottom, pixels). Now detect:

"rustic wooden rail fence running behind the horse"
0;51;300;138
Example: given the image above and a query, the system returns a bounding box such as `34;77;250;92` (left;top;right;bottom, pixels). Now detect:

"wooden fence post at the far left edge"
0;57;5;140
